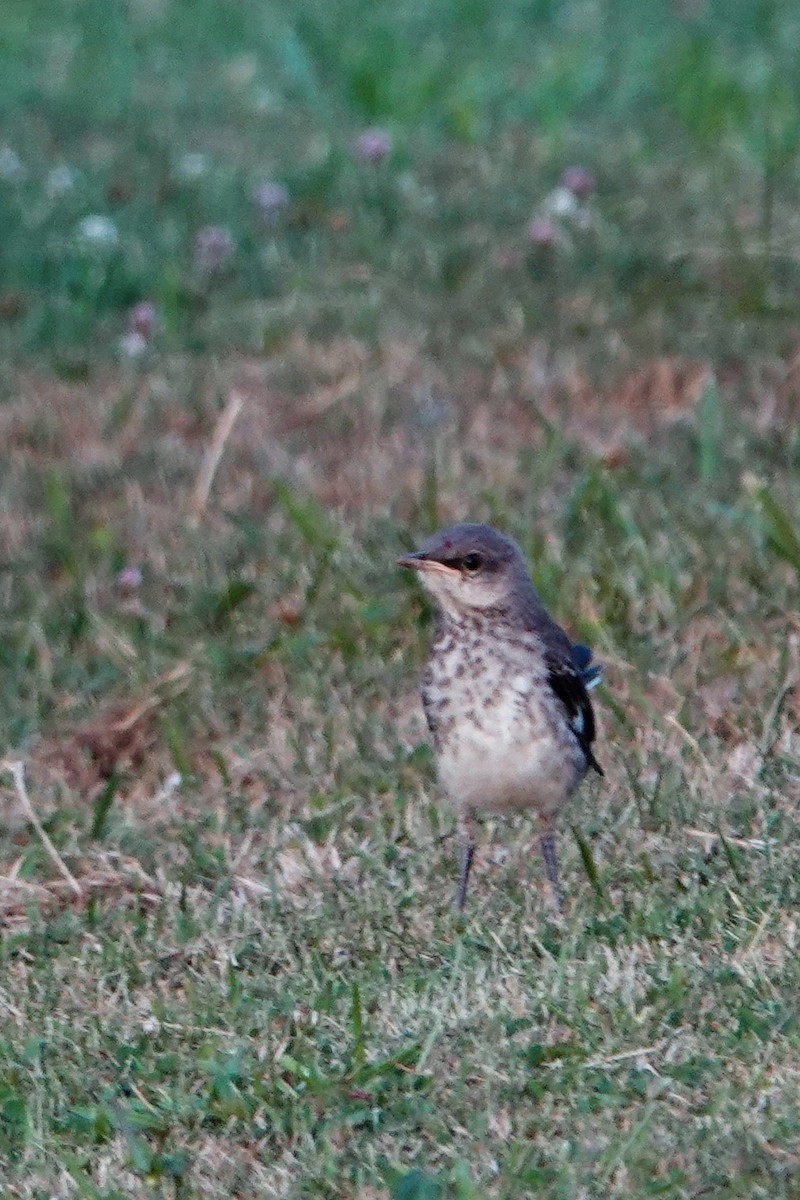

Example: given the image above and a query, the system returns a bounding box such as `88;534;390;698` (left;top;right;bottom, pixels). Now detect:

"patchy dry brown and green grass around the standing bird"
0;340;800;1200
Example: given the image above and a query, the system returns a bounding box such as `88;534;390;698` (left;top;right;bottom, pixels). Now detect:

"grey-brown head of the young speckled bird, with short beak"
397;524;531;616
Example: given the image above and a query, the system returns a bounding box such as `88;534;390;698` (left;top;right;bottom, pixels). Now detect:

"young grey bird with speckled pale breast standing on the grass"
397;523;603;912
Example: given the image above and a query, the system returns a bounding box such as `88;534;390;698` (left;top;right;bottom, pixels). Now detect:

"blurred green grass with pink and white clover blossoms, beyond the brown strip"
0;0;800;373
